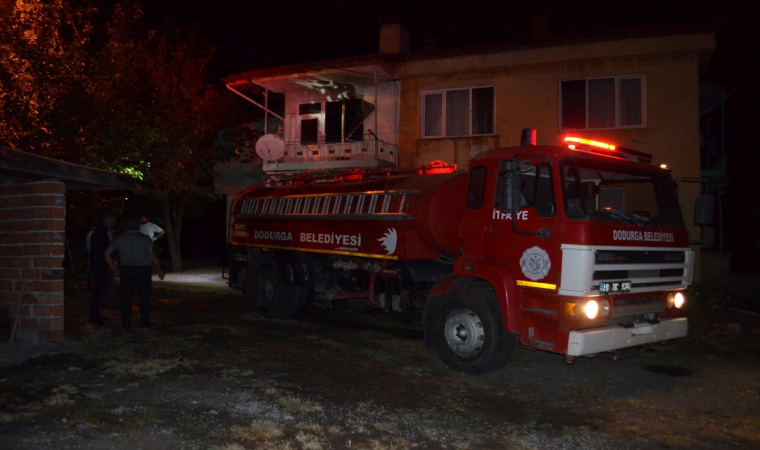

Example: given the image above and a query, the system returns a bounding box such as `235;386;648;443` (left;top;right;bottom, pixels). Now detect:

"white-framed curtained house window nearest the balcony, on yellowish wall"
421;86;494;137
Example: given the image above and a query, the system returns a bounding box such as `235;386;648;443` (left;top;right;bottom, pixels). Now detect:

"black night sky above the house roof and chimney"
131;0;758;77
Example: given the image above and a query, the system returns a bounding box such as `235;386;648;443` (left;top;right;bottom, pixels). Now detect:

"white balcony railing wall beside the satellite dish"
264;135;398;172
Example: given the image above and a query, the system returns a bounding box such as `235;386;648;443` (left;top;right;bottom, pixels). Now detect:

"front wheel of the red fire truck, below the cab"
432;289;517;375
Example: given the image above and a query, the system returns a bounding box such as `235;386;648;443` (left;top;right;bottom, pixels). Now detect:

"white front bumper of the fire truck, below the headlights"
567;317;688;356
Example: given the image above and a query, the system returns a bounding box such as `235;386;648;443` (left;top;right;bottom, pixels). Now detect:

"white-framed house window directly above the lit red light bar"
559;75;644;130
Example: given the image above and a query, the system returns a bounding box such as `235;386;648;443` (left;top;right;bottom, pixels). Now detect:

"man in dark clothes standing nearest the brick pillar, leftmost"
88;214;116;326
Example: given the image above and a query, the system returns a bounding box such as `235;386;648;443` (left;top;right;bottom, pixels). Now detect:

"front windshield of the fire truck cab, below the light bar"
560;156;683;226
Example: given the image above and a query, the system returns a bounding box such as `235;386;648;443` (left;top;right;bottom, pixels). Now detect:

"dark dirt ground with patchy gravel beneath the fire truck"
0;269;760;450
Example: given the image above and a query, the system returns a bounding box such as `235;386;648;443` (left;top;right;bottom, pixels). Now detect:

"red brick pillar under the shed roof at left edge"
0;181;66;341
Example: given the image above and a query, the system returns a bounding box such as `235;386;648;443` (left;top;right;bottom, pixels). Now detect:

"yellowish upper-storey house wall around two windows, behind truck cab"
397;35;714;278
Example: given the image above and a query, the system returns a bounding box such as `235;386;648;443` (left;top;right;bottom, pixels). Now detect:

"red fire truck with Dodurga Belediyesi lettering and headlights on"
230;137;693;373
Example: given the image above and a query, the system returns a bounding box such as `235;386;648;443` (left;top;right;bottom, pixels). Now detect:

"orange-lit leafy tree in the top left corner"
0;0;94;155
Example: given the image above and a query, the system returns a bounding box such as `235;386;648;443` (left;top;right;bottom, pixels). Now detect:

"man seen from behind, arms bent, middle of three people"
105;219;164;330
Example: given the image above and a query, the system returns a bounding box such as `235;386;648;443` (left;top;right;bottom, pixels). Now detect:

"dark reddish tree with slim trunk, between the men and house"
85;6;226;270
